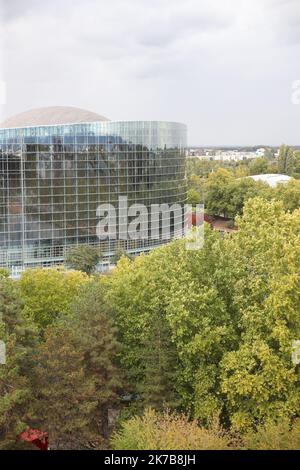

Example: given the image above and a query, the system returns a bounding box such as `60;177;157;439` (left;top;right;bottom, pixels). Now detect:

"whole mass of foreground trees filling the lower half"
0;196;300;449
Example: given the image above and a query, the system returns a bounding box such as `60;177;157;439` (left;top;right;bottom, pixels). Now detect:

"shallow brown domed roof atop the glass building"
0;106;109;129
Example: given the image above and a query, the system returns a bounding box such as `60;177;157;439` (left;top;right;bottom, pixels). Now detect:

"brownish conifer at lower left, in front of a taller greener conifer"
31;324;96;449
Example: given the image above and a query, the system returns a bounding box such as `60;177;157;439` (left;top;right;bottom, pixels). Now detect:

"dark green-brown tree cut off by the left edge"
0;279;34;449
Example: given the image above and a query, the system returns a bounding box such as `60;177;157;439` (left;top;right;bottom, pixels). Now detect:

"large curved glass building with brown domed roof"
0;107;186;271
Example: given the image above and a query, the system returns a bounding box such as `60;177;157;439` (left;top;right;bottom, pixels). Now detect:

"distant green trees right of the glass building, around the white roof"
188;146;300;219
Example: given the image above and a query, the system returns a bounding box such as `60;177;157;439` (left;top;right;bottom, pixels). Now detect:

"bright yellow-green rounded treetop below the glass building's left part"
20;268;89;332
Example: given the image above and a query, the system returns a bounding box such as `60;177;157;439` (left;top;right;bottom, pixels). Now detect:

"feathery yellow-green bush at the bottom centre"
112;409;229;450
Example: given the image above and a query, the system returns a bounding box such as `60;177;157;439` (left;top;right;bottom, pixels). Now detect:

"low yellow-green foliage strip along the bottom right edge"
111;409;300;450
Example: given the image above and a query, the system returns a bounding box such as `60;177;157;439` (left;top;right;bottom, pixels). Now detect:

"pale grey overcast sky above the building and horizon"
0;0;300;145
